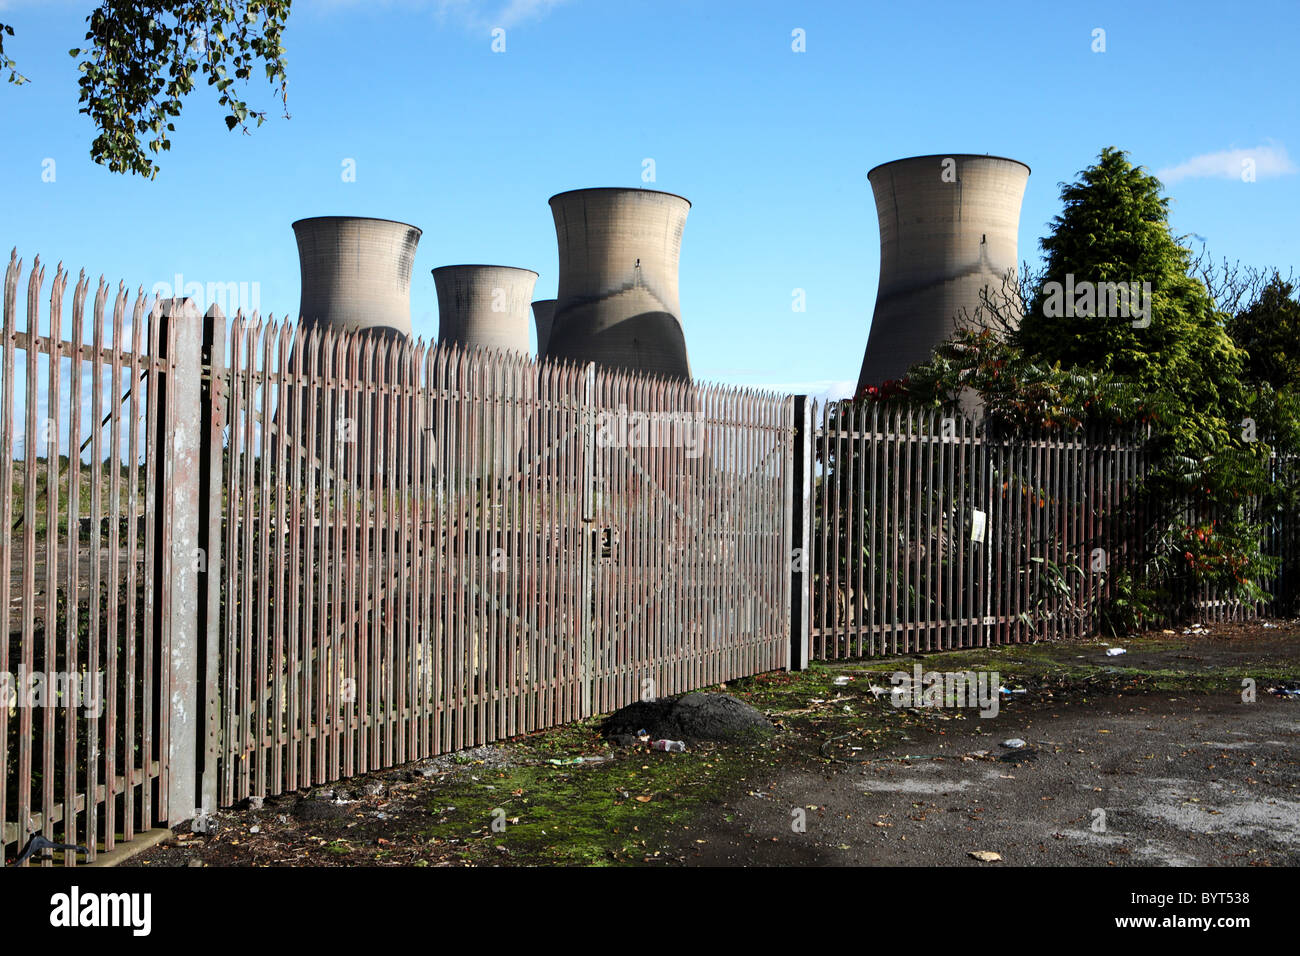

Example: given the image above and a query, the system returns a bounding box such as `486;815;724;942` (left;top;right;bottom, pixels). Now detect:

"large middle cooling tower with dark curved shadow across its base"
546;189;690;378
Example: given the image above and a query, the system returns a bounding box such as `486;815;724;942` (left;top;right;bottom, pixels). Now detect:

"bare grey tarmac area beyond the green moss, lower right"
681;695;1300;866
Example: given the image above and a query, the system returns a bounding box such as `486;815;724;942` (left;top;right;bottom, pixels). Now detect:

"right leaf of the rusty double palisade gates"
588;369;793;713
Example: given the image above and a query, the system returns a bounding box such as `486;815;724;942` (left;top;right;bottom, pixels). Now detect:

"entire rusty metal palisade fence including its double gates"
0;248;1296;866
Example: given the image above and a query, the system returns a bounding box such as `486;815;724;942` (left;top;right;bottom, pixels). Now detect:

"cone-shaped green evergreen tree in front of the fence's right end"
1015;147;1245;454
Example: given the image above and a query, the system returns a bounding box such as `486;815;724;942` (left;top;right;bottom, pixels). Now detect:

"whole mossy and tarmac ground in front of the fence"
122;622;1300;866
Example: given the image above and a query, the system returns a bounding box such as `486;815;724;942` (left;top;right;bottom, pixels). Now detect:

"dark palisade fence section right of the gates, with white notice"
807;402;1296;659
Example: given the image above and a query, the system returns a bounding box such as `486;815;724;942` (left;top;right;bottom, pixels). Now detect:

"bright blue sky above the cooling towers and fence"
0;0;1300;393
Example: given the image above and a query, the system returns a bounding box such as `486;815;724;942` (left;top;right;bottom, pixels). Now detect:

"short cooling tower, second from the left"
433;265;537;355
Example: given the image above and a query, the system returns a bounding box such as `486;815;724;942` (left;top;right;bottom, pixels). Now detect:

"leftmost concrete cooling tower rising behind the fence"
294;216;420;336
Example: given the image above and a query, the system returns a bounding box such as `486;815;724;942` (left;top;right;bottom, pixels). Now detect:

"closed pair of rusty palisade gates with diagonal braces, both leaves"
204;325;792;805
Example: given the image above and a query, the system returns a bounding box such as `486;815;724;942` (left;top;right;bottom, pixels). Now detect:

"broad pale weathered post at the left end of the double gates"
153;299;203;826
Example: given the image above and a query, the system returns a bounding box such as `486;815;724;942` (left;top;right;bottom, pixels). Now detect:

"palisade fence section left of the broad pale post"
0;255;183;864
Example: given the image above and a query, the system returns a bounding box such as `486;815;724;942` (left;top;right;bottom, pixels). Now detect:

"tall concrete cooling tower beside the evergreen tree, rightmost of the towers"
858;153;1030;392
